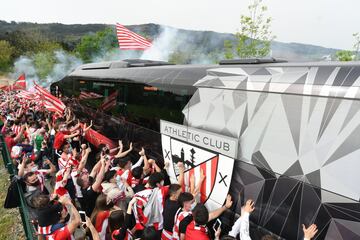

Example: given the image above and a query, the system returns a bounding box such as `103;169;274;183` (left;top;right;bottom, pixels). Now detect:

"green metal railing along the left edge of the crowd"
0;134;37;240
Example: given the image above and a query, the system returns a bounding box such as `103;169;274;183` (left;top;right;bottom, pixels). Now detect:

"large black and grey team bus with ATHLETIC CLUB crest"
51;59;360;240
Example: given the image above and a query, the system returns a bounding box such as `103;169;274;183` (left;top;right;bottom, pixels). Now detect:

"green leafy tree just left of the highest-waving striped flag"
75;28;118;62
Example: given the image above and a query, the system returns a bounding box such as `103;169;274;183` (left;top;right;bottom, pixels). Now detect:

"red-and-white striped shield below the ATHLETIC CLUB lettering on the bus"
162;123;238;209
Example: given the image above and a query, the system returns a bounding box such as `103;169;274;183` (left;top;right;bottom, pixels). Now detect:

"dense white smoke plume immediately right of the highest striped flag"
141;27;178;61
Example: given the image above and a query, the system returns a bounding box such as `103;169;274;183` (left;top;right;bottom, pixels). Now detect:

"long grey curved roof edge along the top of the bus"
69;61;360;86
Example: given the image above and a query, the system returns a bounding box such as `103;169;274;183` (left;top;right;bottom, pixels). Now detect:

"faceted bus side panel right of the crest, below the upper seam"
184;88;360;239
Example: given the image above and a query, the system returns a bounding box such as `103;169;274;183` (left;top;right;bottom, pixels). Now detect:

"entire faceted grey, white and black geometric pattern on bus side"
183;66;360;239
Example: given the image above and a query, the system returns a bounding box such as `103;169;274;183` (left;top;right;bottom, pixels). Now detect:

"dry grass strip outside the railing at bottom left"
0;157;25;240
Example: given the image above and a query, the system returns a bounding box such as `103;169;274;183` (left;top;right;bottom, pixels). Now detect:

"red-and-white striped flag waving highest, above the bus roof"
116;23;152;50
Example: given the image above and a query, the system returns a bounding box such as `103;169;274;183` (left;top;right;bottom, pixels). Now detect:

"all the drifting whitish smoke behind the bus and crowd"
11;26;223;89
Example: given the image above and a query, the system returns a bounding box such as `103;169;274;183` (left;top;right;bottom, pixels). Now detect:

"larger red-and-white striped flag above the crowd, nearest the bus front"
34;82;66;113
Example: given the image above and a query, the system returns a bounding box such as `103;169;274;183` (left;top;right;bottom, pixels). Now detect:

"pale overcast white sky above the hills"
0;0;360;50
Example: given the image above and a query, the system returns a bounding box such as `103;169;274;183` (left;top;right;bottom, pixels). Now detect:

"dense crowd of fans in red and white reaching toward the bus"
0;92;317;240
